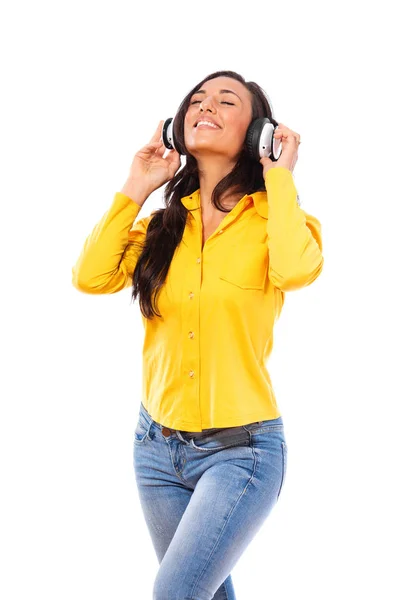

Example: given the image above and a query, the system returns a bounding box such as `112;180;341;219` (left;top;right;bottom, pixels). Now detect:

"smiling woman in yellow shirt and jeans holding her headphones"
73;71;324;600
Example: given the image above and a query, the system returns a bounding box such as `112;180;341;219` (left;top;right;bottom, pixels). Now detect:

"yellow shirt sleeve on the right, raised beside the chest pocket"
265;167;324;292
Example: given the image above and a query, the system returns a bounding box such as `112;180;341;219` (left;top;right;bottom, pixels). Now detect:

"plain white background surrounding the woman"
0;0;400;600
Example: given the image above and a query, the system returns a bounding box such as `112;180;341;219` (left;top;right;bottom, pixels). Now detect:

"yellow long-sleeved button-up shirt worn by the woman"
72;167;324;431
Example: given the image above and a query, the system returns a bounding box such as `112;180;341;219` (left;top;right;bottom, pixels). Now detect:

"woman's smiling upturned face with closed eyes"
184;77;252;159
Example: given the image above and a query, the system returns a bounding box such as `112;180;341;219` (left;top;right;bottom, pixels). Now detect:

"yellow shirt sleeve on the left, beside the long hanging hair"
72;192;152;294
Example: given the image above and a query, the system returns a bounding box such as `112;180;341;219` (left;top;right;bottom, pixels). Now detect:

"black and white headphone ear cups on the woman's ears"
162;117;282;162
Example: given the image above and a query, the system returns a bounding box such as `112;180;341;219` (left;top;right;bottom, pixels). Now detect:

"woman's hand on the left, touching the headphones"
129;121;181;194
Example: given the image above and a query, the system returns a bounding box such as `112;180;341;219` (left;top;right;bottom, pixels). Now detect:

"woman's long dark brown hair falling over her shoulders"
132;71;278;319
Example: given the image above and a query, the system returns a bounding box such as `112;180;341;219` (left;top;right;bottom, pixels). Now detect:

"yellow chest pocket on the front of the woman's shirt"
219;243;268;290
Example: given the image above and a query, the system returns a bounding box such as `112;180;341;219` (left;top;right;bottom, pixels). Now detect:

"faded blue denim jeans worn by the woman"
133;403;287;600
